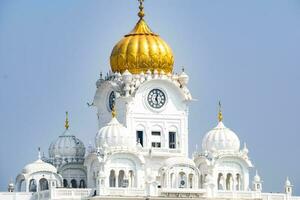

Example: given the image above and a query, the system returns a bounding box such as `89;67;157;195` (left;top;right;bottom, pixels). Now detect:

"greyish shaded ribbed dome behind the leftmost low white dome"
49;129;85;159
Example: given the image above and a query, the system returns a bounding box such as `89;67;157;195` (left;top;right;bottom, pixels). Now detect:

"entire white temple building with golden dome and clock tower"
0;0;300;200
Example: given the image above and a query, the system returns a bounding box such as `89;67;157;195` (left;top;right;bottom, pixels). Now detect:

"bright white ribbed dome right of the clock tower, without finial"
202;121;240;152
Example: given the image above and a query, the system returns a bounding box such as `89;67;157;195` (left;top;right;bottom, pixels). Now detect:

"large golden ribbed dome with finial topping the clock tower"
110;1;174;74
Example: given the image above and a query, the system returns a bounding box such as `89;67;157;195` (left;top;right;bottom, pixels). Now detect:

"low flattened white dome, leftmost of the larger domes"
22;159;57;174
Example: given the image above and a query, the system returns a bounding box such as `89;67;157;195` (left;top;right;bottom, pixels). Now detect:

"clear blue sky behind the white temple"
0;0;300;195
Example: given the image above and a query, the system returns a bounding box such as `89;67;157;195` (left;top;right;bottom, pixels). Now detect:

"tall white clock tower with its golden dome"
93;1;192;171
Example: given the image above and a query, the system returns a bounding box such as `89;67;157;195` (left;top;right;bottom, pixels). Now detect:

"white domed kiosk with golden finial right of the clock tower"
194;103;252;191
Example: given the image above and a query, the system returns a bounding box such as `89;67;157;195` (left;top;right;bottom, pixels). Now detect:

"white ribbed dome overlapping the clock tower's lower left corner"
96;117;136;148
